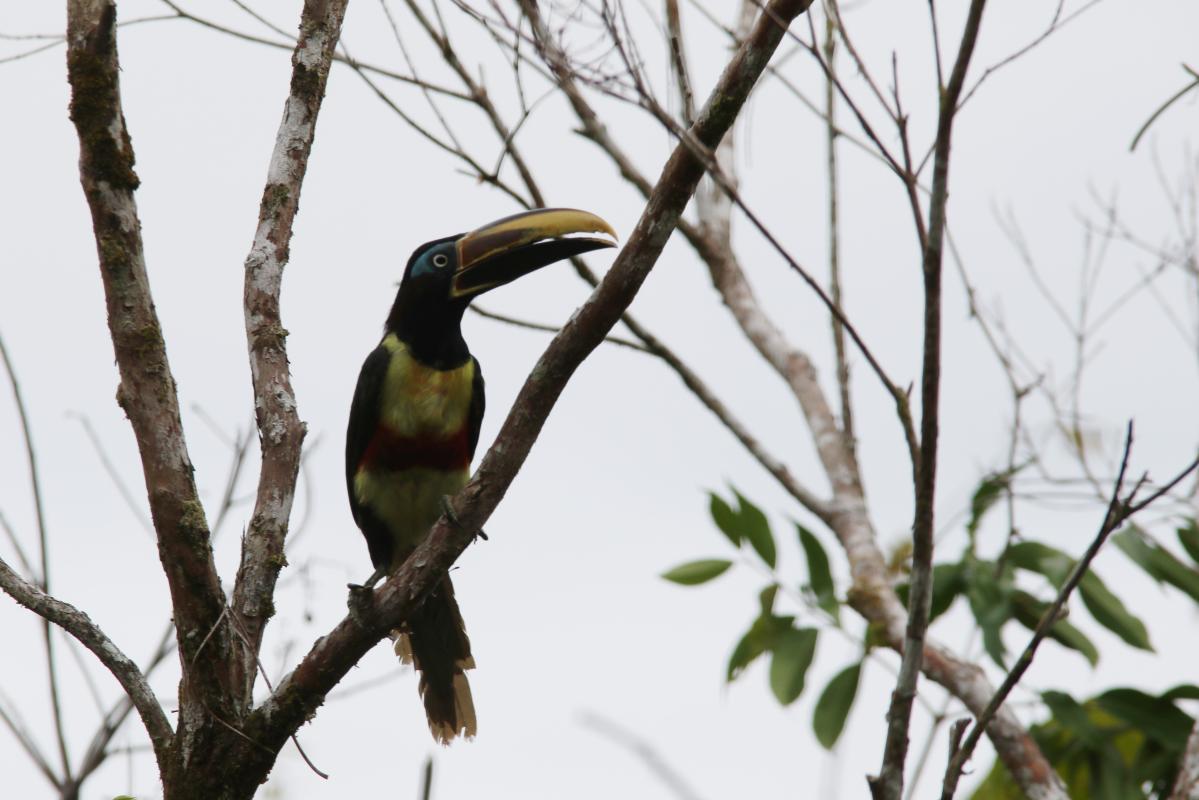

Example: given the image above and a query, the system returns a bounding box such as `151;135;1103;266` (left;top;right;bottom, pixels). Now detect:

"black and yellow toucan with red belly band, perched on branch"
345;209;616;745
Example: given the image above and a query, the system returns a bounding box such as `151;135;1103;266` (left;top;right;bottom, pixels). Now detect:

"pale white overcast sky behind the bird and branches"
0;0;1199;800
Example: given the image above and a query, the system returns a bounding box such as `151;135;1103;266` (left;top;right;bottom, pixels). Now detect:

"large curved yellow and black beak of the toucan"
450;209;616;297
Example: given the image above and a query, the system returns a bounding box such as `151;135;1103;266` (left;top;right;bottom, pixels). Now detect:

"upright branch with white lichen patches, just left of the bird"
233;0;348;708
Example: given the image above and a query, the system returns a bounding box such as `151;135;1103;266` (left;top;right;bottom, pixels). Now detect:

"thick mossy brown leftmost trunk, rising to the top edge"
67;0;229;743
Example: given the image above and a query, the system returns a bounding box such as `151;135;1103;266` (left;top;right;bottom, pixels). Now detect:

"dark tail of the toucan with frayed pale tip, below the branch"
392;576;478;745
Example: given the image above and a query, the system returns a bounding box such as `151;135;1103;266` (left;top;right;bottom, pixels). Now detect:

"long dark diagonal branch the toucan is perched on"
247;0;807;758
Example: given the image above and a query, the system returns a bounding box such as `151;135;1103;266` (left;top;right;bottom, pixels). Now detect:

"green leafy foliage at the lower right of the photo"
663;482;1199;786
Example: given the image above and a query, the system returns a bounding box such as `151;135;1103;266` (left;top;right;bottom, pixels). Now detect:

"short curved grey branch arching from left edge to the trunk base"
0;560;174;764
